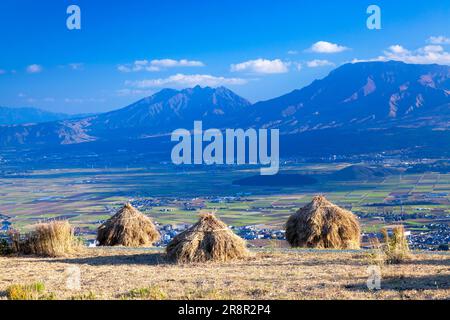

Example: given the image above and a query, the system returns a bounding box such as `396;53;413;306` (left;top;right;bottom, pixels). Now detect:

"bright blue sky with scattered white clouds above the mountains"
0;0;450;113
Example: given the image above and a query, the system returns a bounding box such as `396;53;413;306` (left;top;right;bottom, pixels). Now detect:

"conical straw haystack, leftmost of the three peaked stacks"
97;203;160;247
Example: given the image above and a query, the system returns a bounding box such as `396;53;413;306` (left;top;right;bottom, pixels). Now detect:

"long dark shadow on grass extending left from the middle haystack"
40;253;173;266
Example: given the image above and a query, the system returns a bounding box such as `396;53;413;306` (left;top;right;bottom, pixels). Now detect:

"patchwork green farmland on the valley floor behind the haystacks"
0;164;450;238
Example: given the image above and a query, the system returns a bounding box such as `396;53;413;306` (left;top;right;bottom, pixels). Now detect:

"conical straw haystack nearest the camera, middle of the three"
166;213;249;263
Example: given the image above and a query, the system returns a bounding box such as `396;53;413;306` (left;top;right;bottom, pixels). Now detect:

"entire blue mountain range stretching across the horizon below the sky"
0;61;450;158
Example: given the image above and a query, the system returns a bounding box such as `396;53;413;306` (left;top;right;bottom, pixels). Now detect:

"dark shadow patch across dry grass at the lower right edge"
346;274;450;291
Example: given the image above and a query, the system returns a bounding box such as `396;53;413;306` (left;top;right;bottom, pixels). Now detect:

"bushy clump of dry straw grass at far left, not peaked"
11;221;81;257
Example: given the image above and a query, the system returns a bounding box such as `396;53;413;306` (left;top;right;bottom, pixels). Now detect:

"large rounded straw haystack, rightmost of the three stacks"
286;196;360;249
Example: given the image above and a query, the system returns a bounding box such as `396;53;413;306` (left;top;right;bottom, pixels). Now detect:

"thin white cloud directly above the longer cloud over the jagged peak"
117;59;205;72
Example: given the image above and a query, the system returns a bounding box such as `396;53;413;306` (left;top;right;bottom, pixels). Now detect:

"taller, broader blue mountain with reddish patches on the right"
251;61;450;133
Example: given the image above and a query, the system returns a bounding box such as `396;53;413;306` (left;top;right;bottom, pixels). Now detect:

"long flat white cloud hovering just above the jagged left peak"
125;73;247;89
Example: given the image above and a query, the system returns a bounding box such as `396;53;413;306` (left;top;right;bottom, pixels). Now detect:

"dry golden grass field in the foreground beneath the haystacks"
0;248;450;300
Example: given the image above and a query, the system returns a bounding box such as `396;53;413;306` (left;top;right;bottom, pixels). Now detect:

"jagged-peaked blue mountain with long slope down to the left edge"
0;86;251;146
